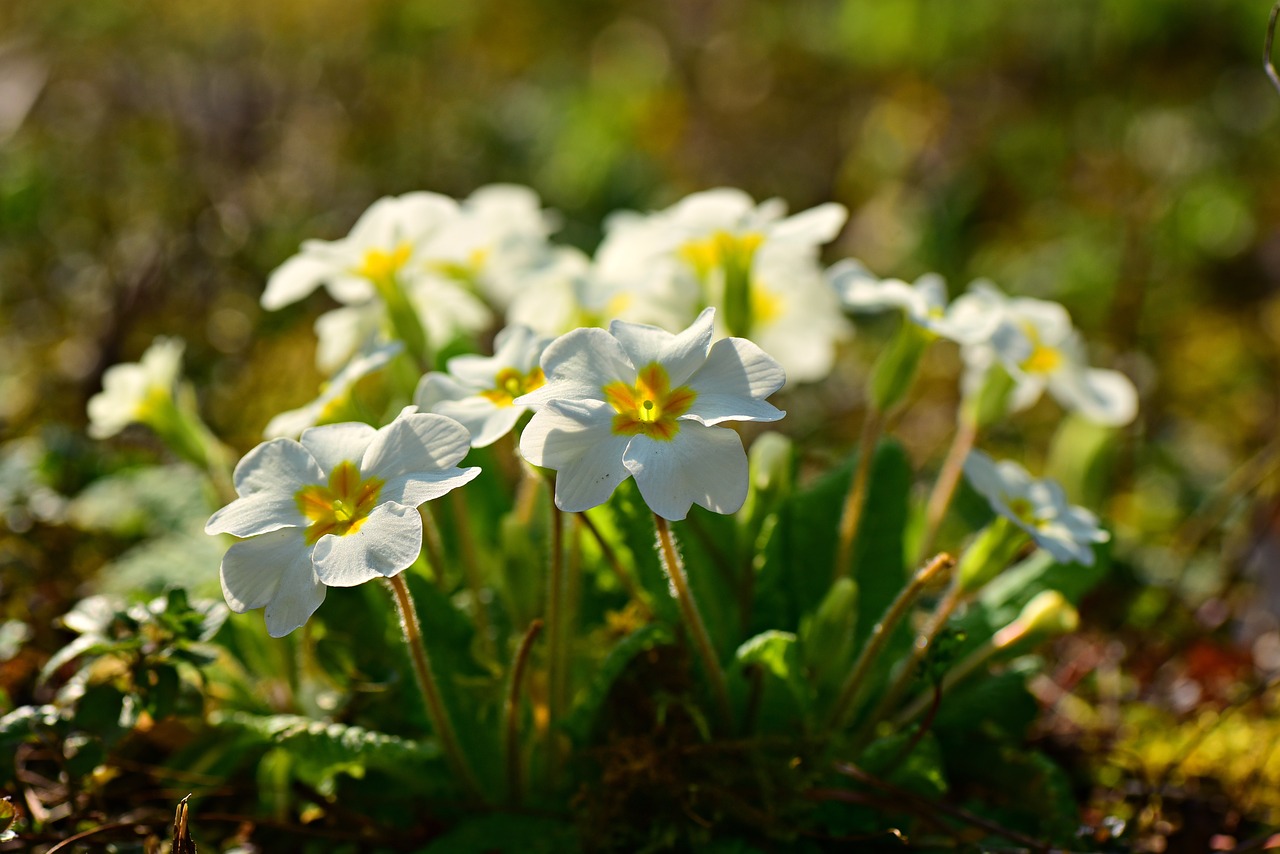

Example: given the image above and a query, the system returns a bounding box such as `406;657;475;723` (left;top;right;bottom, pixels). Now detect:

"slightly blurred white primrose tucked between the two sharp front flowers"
413;326;550;448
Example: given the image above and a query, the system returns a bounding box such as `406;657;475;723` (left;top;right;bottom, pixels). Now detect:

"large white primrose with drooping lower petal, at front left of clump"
205;407;480;638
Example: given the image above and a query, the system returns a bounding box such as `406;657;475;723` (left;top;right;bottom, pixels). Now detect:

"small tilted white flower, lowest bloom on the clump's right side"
964;451;1111;566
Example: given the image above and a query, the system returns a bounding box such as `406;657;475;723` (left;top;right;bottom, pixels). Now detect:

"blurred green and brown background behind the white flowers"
0;0;1280;612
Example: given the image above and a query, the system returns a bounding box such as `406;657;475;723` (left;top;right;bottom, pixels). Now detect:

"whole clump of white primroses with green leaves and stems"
62;186;1137;850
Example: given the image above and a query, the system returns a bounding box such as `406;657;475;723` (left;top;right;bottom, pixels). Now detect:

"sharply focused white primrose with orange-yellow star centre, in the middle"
515;309;786;520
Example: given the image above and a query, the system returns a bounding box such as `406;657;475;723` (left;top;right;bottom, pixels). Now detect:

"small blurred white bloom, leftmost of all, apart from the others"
88;337;186;439
